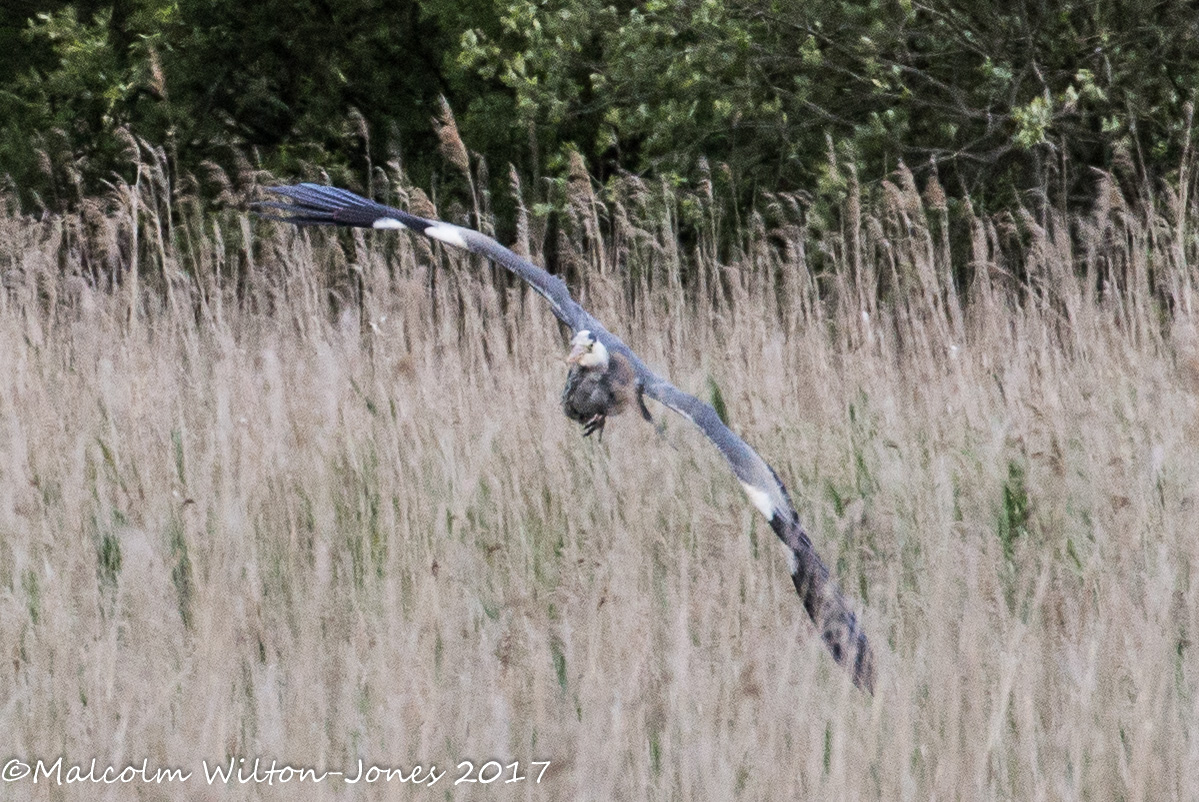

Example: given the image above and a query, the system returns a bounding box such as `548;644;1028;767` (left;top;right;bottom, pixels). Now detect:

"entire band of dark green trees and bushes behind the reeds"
0;0;1199;225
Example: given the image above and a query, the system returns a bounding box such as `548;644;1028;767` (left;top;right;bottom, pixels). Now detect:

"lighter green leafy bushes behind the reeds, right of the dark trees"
458;0;1199;206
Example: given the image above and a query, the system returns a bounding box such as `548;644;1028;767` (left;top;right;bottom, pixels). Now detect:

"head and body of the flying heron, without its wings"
562;328;653;440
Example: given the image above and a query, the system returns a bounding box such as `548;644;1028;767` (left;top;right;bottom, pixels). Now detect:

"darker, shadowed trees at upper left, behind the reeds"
0;0;450;209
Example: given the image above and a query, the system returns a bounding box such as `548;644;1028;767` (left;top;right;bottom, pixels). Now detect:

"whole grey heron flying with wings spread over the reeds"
254;183;874;693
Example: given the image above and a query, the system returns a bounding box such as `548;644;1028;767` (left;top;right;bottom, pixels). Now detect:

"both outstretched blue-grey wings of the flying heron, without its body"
254;183;874;693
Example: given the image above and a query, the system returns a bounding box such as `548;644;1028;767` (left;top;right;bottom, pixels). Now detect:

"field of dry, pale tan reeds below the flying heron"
0;153;1199;801
